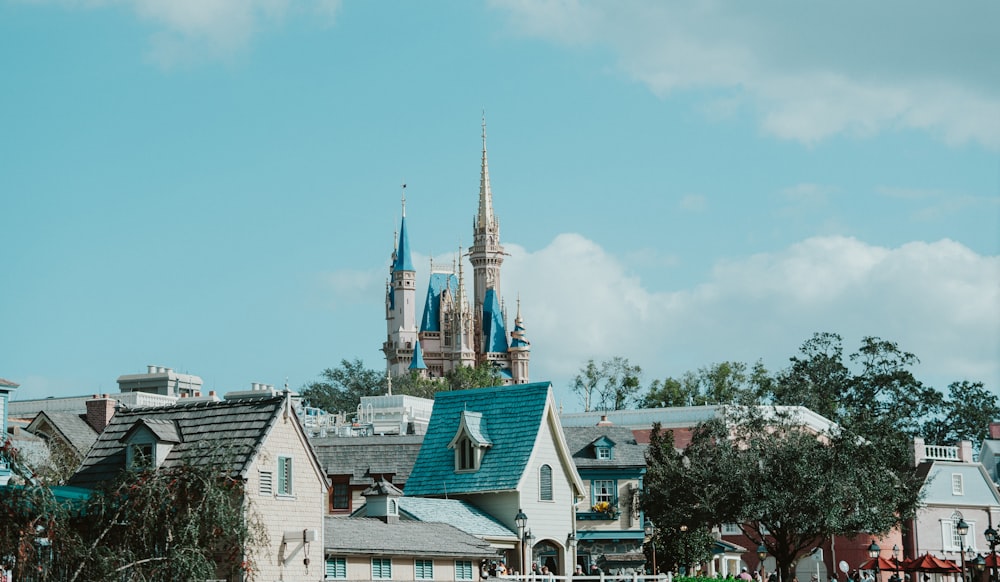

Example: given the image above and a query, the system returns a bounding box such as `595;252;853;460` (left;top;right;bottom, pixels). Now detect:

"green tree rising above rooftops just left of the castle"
302;358;386;414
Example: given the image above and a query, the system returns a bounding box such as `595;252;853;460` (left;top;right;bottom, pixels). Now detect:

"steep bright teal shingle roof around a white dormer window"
404;382;552;496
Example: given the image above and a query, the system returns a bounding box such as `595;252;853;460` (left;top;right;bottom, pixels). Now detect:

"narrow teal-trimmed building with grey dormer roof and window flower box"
563;420;647;573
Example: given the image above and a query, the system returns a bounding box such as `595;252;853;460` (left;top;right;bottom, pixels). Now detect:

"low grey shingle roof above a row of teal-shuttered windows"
323;516;497;558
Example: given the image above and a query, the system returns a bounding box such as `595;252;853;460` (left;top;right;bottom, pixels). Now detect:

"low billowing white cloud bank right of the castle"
504;234;1000;405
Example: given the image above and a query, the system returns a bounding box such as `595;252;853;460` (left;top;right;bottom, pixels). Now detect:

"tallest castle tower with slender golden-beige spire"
469;116;504;354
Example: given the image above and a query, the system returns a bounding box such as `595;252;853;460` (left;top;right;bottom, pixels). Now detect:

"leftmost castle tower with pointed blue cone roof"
382;184;417;376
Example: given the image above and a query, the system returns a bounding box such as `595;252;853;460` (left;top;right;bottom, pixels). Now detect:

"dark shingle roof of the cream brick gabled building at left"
69;396;294;487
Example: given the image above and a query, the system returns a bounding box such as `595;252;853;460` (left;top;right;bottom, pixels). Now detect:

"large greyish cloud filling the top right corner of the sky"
494;0;1000;148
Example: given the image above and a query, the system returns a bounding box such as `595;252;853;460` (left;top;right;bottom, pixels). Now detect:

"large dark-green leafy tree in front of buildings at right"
643;407;920;580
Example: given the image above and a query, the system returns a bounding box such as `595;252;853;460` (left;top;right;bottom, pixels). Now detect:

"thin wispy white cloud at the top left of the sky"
39;0;341;68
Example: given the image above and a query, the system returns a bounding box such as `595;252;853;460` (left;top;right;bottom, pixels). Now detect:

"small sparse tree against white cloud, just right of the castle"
572;356;642;411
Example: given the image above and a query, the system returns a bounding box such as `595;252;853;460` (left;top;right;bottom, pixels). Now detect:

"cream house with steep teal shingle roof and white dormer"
405;382;587;575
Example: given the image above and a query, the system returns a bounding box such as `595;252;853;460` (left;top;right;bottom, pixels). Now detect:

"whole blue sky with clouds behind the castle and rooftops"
0;0;1000;411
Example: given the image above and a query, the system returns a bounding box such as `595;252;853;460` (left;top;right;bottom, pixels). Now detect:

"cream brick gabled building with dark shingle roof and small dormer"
69;391;327;580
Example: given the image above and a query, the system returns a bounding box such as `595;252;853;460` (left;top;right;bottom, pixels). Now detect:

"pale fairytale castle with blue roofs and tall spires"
382;119;531;385
